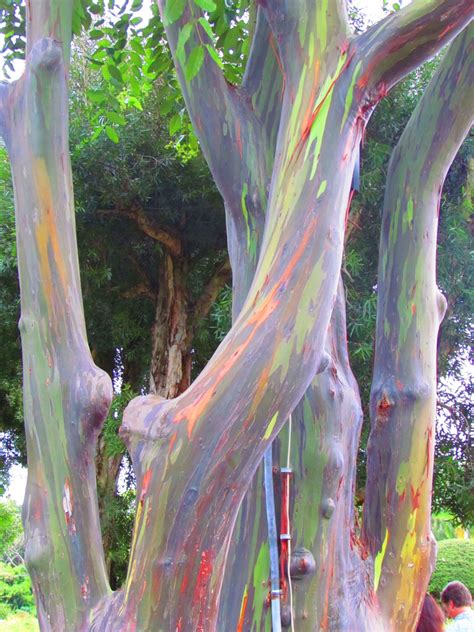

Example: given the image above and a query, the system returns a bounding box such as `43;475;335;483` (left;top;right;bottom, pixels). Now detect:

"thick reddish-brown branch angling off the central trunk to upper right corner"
356;0;474;100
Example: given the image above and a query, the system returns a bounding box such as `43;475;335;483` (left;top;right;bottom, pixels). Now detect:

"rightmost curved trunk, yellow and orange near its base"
362;25;474;629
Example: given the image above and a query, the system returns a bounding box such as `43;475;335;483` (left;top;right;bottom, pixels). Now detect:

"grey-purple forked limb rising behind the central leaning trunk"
159;0;281;306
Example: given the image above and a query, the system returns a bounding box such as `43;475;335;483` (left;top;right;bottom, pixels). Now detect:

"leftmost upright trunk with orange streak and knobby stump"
1;0;112;630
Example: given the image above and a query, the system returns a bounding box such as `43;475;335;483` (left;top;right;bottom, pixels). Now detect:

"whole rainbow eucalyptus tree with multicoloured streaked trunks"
1;0;473;632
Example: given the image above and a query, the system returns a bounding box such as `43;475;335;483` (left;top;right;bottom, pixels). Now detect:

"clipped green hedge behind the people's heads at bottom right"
428;539;474;598
